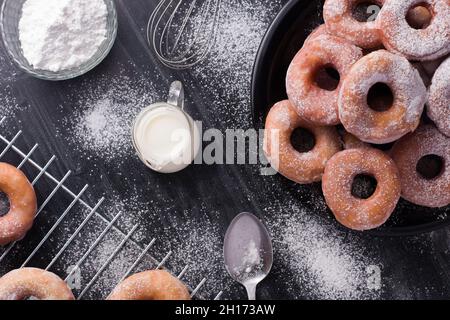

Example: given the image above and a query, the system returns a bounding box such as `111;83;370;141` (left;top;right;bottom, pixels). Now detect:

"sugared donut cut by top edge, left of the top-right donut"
323;0;385;49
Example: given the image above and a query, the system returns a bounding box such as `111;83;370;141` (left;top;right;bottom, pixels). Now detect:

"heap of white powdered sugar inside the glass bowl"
19;0;108;72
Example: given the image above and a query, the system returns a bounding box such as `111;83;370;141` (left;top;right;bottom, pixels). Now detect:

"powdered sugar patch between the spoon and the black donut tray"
266;200;381;299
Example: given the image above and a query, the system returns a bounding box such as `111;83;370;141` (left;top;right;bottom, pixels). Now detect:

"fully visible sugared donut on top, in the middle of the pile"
339;50;427;144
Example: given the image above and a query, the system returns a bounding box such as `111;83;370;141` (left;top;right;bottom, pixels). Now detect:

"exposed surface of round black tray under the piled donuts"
252;0;450;236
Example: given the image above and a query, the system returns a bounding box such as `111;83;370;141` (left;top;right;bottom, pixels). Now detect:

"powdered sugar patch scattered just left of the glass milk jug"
63;69;158;161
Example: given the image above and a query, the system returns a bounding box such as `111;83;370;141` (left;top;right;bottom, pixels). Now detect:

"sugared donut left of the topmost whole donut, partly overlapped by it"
286;35;363;126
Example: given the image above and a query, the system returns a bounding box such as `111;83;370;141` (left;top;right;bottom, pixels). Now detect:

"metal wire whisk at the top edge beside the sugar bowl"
147;0;222;69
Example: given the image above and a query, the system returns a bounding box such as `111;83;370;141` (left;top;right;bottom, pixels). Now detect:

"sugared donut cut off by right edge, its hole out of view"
427;58;450;137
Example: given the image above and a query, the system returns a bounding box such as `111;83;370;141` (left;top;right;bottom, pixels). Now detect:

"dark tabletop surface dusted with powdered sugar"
0;0;450;299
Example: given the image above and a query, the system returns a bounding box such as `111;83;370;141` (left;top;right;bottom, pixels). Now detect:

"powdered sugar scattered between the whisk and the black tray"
187;0;282;128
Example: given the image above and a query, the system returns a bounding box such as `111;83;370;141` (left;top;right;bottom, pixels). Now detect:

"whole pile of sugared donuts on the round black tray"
264;0;450;231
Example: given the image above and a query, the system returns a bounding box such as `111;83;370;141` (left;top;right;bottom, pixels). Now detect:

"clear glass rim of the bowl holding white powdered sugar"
0;0;118;81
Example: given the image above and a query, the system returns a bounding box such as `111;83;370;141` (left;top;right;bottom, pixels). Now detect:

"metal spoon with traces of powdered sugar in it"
223;212;273;300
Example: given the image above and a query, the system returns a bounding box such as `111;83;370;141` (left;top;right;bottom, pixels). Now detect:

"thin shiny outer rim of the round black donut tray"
250;0;450;238
